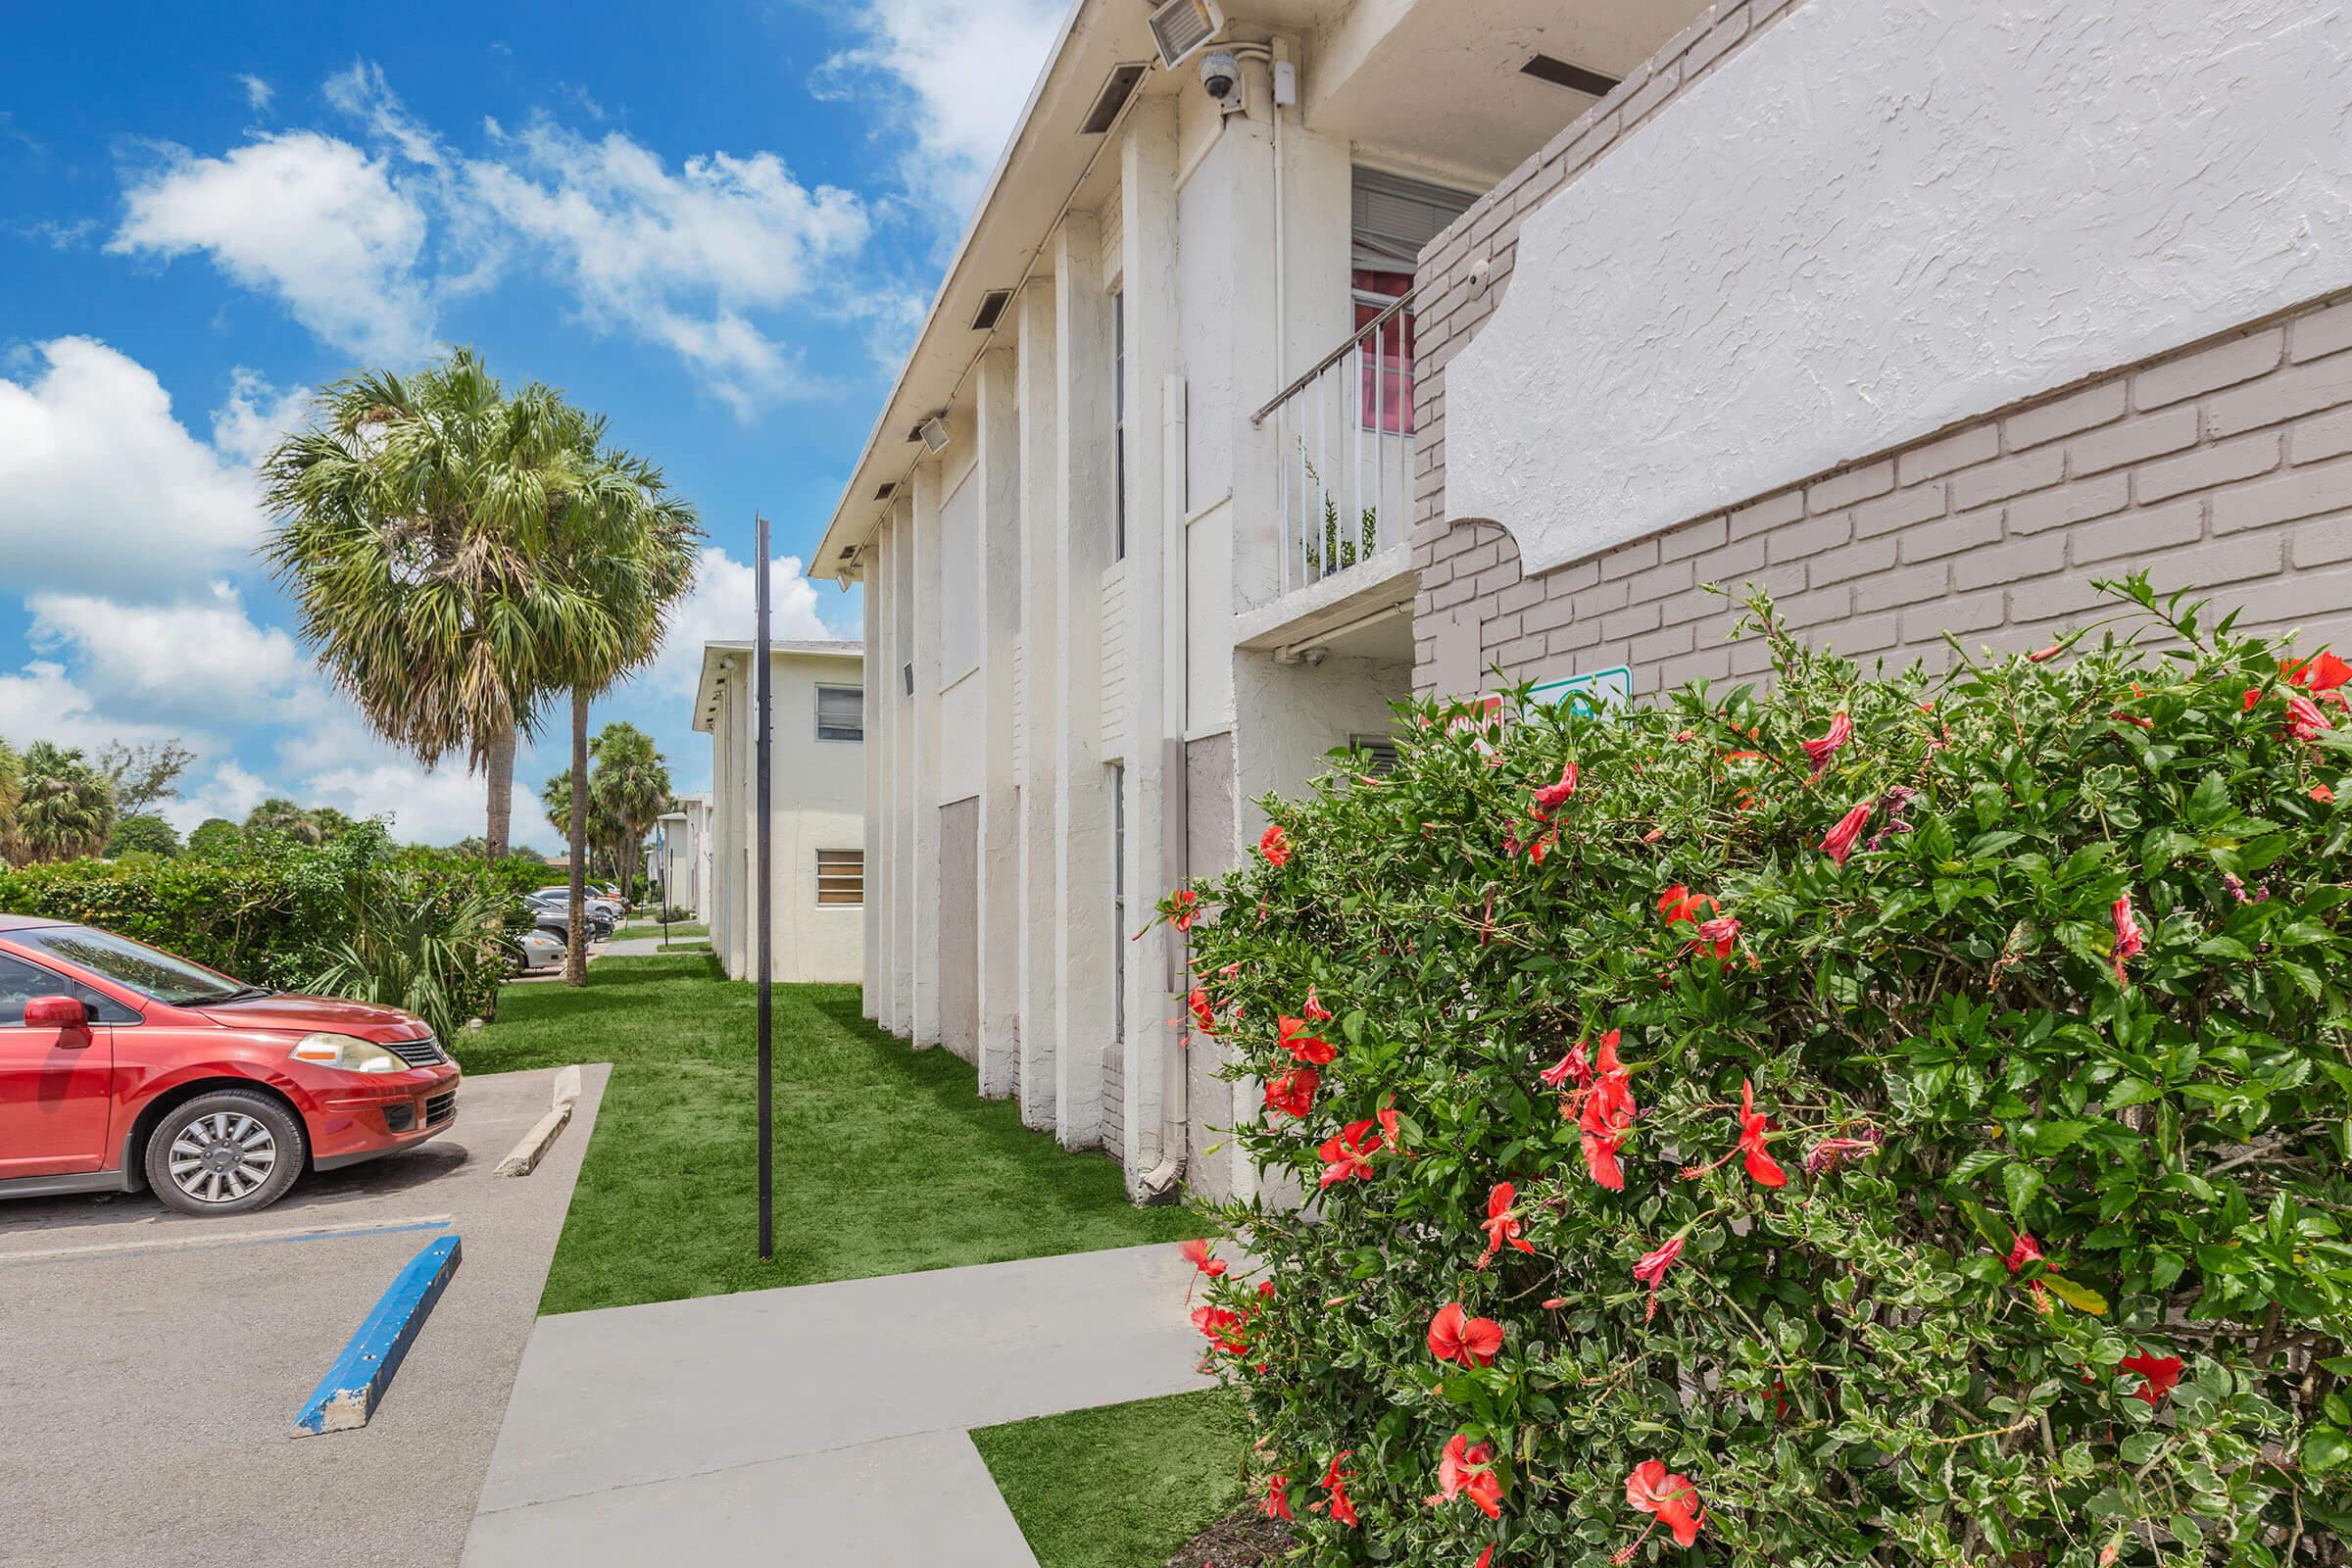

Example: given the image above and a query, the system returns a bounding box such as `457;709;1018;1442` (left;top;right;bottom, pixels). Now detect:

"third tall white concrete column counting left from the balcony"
1013;277;1065;1128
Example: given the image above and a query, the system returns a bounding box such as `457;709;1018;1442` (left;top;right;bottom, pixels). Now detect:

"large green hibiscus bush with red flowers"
1162;578;2352;1568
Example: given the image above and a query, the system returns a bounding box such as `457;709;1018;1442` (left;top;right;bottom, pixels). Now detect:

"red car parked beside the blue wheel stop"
0;914;459;1215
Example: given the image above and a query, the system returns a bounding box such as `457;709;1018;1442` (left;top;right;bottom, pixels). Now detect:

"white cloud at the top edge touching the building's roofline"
816;0;1068;220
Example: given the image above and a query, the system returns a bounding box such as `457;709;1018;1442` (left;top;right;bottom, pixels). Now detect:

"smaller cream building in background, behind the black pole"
694;642;870;983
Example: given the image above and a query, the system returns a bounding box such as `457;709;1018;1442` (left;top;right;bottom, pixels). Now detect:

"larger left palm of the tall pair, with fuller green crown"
261;348;602;860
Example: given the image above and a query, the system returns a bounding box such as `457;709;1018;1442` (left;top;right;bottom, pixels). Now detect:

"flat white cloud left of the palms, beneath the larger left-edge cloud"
25;583;313;719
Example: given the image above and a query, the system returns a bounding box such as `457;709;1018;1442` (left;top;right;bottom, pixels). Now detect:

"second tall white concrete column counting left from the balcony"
1054;212;1119;1150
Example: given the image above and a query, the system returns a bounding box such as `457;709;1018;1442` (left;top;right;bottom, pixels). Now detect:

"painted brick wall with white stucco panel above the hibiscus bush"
1411;0;2352;696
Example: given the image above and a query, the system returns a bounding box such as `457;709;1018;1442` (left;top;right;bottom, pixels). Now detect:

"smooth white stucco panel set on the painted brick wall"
1446;0;2352;573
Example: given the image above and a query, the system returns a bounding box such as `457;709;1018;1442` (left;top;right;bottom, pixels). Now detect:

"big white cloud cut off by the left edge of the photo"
0;338;264;592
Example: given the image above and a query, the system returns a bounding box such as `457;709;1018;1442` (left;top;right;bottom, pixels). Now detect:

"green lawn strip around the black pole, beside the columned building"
459;955;1198;1312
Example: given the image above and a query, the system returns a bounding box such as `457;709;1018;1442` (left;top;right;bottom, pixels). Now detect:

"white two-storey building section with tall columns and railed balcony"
811;0;1698;1197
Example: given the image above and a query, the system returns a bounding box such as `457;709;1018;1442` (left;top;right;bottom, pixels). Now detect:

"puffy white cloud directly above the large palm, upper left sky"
106;131;433;360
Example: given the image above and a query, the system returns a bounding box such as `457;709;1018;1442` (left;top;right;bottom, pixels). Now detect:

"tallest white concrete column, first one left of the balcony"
1119;99;1186;1190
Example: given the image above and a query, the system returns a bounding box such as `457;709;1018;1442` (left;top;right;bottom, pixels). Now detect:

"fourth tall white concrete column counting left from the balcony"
973;348;1021;1101
